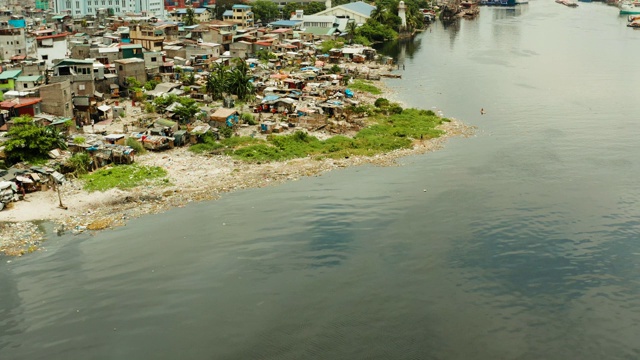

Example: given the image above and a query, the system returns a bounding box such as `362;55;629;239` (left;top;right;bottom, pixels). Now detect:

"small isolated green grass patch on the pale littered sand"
81;164;169;191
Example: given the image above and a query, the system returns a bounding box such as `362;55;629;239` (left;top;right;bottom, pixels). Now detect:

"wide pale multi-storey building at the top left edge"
52;0;164;17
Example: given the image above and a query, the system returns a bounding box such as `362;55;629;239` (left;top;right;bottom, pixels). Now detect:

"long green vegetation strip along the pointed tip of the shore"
191;109;448;162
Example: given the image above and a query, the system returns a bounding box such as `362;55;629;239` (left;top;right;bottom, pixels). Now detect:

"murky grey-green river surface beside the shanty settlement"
0;0;640;360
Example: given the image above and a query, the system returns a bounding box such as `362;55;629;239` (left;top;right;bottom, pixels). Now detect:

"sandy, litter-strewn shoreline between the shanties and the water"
0;76;474;256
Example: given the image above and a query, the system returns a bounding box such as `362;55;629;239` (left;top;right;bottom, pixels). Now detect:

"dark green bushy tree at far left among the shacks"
4;116;67;162
